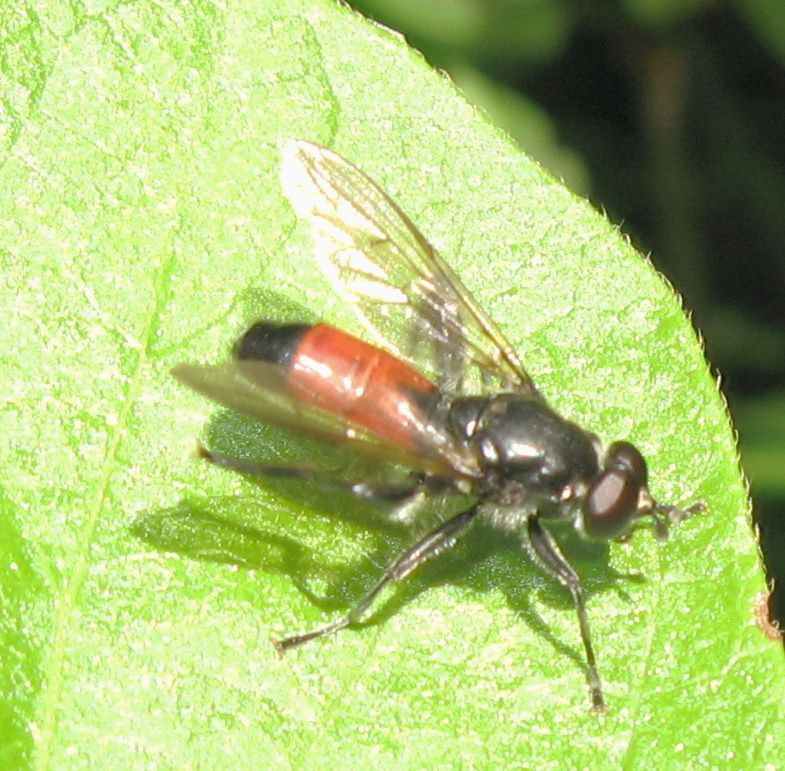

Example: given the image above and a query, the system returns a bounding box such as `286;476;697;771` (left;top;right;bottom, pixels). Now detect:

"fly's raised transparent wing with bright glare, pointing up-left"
281;140;539;398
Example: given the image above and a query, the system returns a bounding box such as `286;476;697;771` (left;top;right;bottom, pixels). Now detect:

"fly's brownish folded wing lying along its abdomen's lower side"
172;360;479;478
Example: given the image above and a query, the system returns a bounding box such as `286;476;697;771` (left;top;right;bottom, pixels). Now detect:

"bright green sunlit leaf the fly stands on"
0;0;785;768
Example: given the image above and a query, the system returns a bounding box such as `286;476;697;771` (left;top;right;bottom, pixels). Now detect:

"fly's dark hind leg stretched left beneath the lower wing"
197;444;422;504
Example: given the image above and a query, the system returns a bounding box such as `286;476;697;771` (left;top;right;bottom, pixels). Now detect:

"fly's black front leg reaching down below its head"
526;515;605;710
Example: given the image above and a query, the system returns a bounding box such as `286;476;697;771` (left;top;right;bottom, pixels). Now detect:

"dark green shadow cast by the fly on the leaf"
131;411;645;667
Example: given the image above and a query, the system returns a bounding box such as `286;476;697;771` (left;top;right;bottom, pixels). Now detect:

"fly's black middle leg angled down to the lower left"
274;504;479;653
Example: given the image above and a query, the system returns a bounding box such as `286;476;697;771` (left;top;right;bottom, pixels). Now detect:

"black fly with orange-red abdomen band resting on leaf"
173;140;703;709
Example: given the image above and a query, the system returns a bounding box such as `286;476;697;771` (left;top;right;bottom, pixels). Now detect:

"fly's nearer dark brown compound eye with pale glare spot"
583;468;641;540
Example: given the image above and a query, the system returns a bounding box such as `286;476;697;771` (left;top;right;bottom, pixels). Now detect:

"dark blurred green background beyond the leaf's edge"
351;0;785;628
